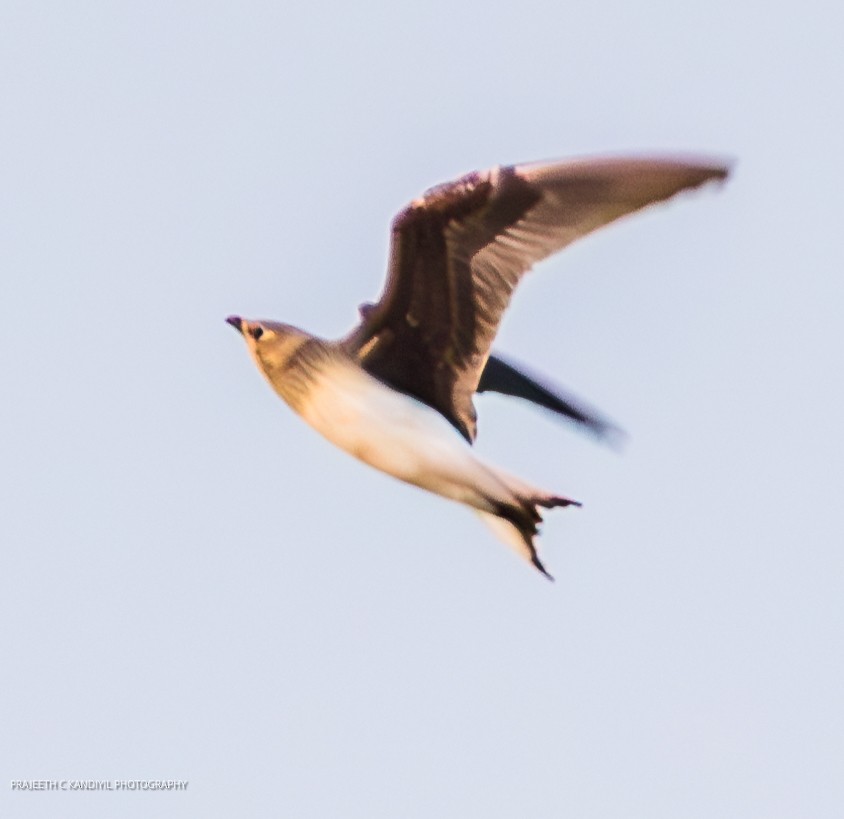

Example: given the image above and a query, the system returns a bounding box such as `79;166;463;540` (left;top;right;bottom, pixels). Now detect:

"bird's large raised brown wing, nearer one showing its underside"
347;159;727;442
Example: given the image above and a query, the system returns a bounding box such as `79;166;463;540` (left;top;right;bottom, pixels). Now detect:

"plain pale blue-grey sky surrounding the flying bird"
0;0;844;819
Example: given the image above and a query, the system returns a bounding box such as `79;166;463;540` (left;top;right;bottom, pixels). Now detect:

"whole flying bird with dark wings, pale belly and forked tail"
226;157;728;578
